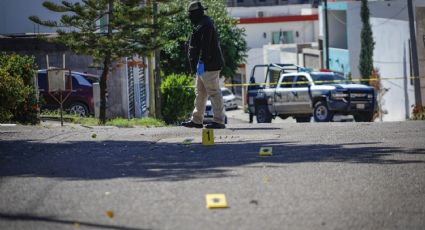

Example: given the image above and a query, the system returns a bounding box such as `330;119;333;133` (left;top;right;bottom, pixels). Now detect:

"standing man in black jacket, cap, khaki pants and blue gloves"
182;1;226;129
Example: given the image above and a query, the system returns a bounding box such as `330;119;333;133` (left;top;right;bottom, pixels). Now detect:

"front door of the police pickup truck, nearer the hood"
290;75;311;113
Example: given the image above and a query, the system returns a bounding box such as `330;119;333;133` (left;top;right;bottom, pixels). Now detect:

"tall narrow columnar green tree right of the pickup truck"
359;0;375;84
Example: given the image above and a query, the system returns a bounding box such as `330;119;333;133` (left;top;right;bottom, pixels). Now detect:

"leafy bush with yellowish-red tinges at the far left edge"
0;53;39;124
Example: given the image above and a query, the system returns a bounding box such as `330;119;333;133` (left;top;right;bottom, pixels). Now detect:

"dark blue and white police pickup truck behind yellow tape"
247;64;376;123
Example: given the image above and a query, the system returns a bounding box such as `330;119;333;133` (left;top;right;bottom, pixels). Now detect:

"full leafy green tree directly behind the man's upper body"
161;0;247;78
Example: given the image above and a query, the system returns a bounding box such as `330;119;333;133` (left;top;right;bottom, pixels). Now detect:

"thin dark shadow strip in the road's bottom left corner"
0;213;144;230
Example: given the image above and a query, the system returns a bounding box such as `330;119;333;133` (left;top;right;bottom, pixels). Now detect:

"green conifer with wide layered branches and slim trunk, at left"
30;0;175;124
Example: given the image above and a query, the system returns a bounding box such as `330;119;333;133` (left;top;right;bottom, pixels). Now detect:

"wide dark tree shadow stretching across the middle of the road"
0;140;425;181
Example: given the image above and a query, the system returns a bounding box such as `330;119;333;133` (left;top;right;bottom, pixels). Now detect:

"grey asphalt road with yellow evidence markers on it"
0;121;425;230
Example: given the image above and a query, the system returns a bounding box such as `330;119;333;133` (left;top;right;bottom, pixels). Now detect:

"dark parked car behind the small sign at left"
37;70;96;116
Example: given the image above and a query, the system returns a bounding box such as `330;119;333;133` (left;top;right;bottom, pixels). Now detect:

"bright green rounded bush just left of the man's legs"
161;74;195;124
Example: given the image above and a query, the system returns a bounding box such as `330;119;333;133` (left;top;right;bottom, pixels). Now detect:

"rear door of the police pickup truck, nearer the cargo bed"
273;76;295;114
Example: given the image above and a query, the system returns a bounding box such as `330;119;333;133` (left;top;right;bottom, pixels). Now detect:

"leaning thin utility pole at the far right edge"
407;0;422;106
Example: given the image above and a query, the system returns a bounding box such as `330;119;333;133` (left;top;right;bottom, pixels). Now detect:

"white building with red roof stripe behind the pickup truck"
228;4;319;103
